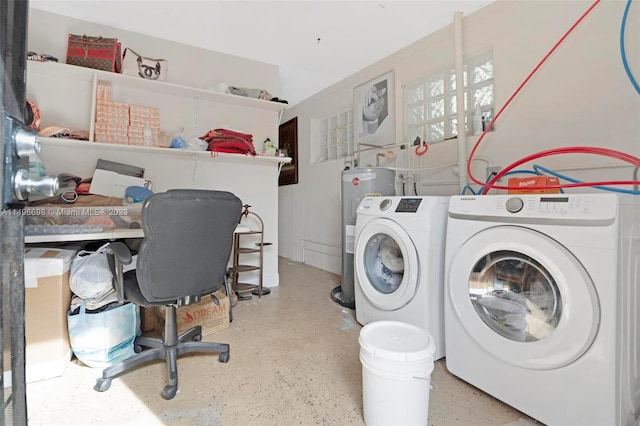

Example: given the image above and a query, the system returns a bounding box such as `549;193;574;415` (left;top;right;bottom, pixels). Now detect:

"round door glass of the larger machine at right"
469;251;562;342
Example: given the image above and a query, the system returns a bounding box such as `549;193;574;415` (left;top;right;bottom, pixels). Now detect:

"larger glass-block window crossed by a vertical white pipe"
404;53;495;143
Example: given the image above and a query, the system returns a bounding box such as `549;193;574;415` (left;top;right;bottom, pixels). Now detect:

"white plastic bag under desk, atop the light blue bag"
69;243;113;299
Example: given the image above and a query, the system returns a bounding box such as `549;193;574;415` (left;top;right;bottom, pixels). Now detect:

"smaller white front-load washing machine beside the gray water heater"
354;196;449;360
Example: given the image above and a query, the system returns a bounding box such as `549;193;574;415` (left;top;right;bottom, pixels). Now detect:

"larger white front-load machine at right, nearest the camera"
445;192;640;426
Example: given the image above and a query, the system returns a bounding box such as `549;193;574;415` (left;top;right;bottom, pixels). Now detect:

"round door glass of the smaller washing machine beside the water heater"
363;233;404;294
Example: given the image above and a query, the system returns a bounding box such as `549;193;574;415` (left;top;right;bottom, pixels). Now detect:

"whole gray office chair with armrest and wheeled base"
94;189;242;399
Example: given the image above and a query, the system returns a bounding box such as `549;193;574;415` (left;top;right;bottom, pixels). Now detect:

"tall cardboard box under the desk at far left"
21;248;76;383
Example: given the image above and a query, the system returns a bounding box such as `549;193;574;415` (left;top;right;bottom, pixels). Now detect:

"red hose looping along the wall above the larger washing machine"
467;0;640;195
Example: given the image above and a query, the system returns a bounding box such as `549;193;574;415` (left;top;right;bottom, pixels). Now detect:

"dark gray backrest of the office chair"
136;189;242;303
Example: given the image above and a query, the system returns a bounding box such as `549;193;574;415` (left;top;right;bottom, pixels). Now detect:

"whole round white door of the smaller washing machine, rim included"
353;218;424;311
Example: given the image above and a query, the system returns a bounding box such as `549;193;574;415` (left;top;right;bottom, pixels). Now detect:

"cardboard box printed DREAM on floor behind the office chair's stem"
141;290;229;336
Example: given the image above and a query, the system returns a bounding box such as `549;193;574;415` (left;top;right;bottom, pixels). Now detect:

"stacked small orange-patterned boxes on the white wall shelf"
94;82;160;146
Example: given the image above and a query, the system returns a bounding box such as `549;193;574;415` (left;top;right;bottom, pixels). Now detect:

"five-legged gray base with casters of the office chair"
94;305;229;399
